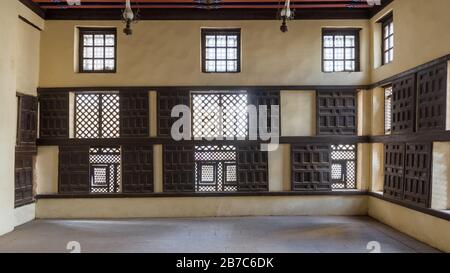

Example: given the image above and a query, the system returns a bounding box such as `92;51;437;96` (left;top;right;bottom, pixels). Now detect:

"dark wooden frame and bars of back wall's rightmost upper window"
322;28;362;73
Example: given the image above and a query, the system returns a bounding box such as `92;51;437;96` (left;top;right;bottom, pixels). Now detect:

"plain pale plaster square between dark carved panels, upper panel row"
280;91;316;136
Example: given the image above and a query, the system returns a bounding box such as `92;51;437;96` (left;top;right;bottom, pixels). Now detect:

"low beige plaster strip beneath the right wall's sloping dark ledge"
368;197;450;252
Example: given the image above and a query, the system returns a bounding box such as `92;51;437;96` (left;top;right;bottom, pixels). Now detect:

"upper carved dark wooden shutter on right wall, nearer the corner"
392;75;415;134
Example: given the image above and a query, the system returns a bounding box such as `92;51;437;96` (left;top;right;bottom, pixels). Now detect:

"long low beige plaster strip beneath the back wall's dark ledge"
36;196;368;219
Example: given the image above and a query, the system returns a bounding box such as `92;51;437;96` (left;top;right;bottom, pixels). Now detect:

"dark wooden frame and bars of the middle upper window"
201;28;242;74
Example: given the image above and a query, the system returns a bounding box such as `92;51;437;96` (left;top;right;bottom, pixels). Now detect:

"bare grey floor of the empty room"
0;216;437;253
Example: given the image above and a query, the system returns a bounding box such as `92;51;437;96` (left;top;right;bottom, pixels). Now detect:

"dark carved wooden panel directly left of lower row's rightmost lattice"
291;144;332;191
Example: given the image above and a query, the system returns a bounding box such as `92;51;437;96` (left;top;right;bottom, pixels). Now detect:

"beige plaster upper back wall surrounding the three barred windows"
40;20;370;87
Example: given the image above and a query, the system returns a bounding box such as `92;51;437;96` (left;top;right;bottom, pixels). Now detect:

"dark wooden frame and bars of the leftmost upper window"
78;27;117;73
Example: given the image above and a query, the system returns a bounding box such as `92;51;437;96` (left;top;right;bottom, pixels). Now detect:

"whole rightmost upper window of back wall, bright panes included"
322;28;360;72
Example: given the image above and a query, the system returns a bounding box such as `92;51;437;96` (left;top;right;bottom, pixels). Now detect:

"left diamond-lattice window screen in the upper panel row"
75;93;120;138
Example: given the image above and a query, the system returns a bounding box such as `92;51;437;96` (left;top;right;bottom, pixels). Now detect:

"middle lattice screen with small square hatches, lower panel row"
195;146;237;192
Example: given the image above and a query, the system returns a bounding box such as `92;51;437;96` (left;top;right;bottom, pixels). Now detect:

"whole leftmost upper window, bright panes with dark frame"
79;28;116;73
